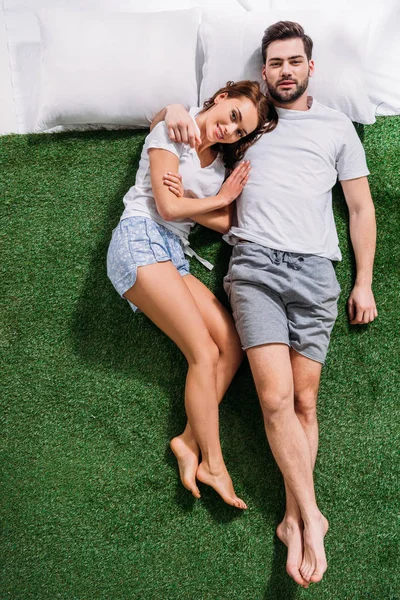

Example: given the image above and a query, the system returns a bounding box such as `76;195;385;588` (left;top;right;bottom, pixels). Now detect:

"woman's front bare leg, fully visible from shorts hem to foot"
124;261;246;508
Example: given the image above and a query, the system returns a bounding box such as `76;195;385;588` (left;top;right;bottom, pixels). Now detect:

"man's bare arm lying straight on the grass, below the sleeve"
340;177;378;325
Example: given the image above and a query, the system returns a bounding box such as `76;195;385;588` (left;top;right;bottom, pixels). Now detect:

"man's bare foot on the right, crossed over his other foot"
300;513;329;583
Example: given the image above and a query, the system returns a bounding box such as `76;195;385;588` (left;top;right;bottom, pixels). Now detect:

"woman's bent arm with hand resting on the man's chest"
149;148;250;221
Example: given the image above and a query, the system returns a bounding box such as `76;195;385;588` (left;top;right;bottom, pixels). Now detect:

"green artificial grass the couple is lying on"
0;117;400;600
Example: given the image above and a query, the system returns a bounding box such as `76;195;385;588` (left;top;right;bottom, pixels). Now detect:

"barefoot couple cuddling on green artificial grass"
107;21;377;587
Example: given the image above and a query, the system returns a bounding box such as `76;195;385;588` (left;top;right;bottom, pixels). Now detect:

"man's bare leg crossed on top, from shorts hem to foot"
247;344;328;584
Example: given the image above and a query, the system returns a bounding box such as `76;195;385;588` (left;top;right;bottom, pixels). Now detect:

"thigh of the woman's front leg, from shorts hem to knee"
124;261;218;362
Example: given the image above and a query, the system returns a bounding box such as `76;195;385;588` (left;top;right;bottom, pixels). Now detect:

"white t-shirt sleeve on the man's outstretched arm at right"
336;119;369;181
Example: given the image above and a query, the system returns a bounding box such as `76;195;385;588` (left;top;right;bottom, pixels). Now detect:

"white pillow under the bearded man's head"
200;10;375;123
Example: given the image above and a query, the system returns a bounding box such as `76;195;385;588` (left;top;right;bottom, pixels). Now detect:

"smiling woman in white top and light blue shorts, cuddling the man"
107;81;277;509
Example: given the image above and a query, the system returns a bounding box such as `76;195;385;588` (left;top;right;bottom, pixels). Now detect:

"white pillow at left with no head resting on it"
37;8;201;130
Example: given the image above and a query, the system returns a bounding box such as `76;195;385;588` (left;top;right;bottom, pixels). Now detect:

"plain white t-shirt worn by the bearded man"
224;99;369;260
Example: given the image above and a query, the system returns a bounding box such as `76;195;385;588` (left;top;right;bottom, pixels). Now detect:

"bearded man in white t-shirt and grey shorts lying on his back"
152;21;377;587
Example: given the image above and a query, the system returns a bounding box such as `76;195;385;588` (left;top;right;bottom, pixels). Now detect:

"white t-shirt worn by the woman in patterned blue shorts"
121;107;225;241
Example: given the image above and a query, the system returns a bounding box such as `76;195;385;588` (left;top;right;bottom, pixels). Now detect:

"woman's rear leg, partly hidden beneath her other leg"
171;275;244;492
